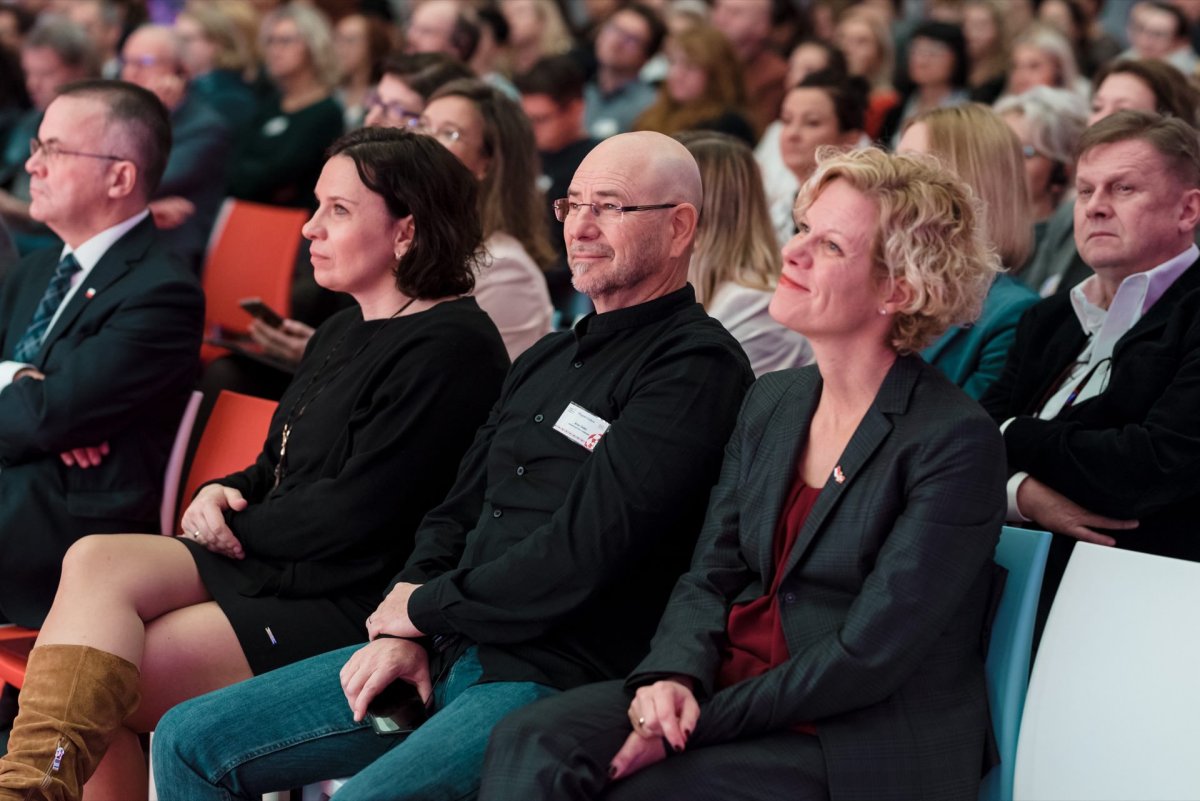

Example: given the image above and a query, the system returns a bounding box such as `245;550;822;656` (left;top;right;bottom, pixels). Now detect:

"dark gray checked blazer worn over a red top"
630;356;1006;801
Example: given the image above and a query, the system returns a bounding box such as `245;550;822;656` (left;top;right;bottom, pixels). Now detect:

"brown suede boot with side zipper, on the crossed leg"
0;645;140;801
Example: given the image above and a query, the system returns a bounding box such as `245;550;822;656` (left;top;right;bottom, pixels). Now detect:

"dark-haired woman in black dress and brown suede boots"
0;130;508;799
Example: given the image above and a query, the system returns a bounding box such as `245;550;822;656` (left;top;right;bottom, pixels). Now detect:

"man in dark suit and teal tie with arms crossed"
0;80;204;626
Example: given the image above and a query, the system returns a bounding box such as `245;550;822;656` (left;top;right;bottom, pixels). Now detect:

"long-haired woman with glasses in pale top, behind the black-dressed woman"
420;79;554;360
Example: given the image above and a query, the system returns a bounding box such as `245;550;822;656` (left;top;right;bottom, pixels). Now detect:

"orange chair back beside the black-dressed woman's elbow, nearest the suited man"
176;391;278;531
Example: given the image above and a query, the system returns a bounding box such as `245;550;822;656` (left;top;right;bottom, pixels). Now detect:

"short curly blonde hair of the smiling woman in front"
796;146;1002;354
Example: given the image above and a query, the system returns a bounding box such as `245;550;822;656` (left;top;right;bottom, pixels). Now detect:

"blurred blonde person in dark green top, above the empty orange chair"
229;4;342;209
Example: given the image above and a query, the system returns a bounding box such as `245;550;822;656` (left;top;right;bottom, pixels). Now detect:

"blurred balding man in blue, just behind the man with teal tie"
121;25;234;273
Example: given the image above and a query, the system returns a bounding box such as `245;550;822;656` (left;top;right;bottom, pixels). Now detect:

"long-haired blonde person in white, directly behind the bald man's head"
676;131;812;377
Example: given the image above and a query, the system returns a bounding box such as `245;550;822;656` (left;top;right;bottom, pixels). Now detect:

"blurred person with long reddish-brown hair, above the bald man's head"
634;23;757;146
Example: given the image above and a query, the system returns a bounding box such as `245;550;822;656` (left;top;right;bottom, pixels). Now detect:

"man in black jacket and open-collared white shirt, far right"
983;112;1200;612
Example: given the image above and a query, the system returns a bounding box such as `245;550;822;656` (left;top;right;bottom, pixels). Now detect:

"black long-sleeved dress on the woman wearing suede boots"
184;299;509;674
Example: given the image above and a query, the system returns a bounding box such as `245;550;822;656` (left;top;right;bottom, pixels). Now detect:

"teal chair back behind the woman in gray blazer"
979;525;1050;801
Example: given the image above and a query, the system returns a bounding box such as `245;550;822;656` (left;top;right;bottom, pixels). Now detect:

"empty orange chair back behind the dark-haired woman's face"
200;198;308;363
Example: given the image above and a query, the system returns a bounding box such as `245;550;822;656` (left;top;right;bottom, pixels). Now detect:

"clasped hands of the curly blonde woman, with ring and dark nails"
608;676;700;779
